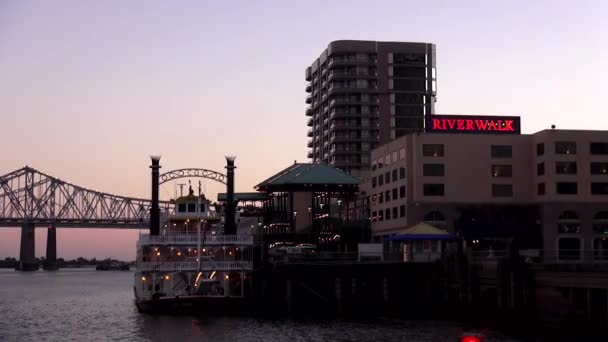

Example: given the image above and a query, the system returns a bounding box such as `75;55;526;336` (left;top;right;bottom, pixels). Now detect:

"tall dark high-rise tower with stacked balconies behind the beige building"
306;40;436;178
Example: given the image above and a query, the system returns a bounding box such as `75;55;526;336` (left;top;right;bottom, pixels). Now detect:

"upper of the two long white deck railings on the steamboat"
138;234;253;246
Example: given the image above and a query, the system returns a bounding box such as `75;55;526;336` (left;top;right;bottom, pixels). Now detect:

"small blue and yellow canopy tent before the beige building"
389;222;452;262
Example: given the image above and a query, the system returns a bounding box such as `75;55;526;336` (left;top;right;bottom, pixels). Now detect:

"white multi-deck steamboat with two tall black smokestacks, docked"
134;158;253;313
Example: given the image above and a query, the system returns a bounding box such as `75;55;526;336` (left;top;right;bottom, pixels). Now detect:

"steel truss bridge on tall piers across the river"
0;162;226;270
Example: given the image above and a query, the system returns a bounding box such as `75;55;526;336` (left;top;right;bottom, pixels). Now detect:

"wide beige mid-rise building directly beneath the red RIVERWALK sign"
364;116;608;259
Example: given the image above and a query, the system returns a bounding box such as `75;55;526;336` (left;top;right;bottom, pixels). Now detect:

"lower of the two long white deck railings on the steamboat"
137;260;253;271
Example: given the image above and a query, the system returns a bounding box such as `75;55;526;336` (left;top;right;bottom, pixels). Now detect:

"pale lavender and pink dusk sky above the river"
0;0;608;259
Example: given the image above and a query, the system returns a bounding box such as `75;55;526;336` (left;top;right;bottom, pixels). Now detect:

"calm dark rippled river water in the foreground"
0;269;516;342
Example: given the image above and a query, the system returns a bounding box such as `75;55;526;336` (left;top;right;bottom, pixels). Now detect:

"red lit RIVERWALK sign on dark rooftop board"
425;115;521;134
